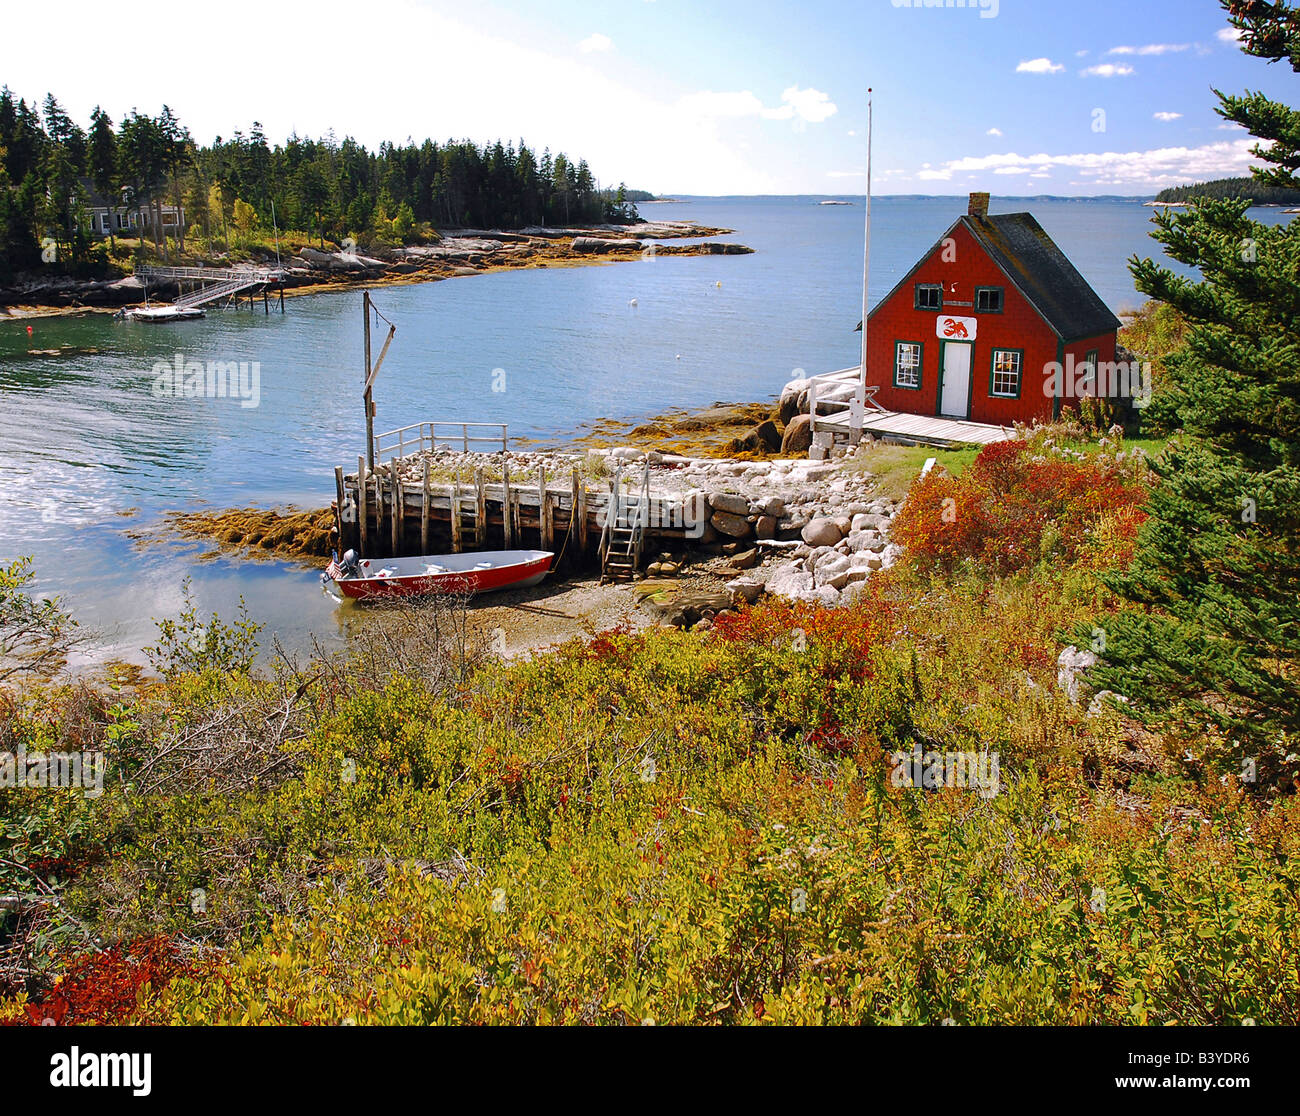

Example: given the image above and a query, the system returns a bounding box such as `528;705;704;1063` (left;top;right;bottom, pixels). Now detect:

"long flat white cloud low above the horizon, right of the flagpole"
917;139;1256;189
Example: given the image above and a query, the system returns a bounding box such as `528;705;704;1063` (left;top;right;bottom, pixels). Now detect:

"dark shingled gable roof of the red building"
858;213;1122;341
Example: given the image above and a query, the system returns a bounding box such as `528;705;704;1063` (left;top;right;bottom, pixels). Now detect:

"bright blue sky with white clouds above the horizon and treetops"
0;0;1297;195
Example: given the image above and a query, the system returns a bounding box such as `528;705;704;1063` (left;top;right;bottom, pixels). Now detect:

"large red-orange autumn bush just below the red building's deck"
892;440;1147;574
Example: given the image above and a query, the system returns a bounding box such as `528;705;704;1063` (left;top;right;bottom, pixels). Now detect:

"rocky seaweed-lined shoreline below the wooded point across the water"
0;221;753;319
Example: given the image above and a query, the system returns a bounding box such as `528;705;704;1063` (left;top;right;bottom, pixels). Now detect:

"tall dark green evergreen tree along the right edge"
1095;3;1300;782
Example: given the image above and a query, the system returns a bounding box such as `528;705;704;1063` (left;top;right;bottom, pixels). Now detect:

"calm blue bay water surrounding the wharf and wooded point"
0;198;1287;659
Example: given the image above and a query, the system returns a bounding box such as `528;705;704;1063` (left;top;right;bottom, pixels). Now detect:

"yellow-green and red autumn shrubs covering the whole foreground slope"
0;463;1300;1025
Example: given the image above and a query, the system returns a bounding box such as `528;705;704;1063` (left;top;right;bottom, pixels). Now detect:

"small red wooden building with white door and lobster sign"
866;194;1121;425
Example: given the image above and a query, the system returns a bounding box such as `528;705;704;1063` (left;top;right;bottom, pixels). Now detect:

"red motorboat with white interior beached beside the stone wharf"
321;550;555;601
